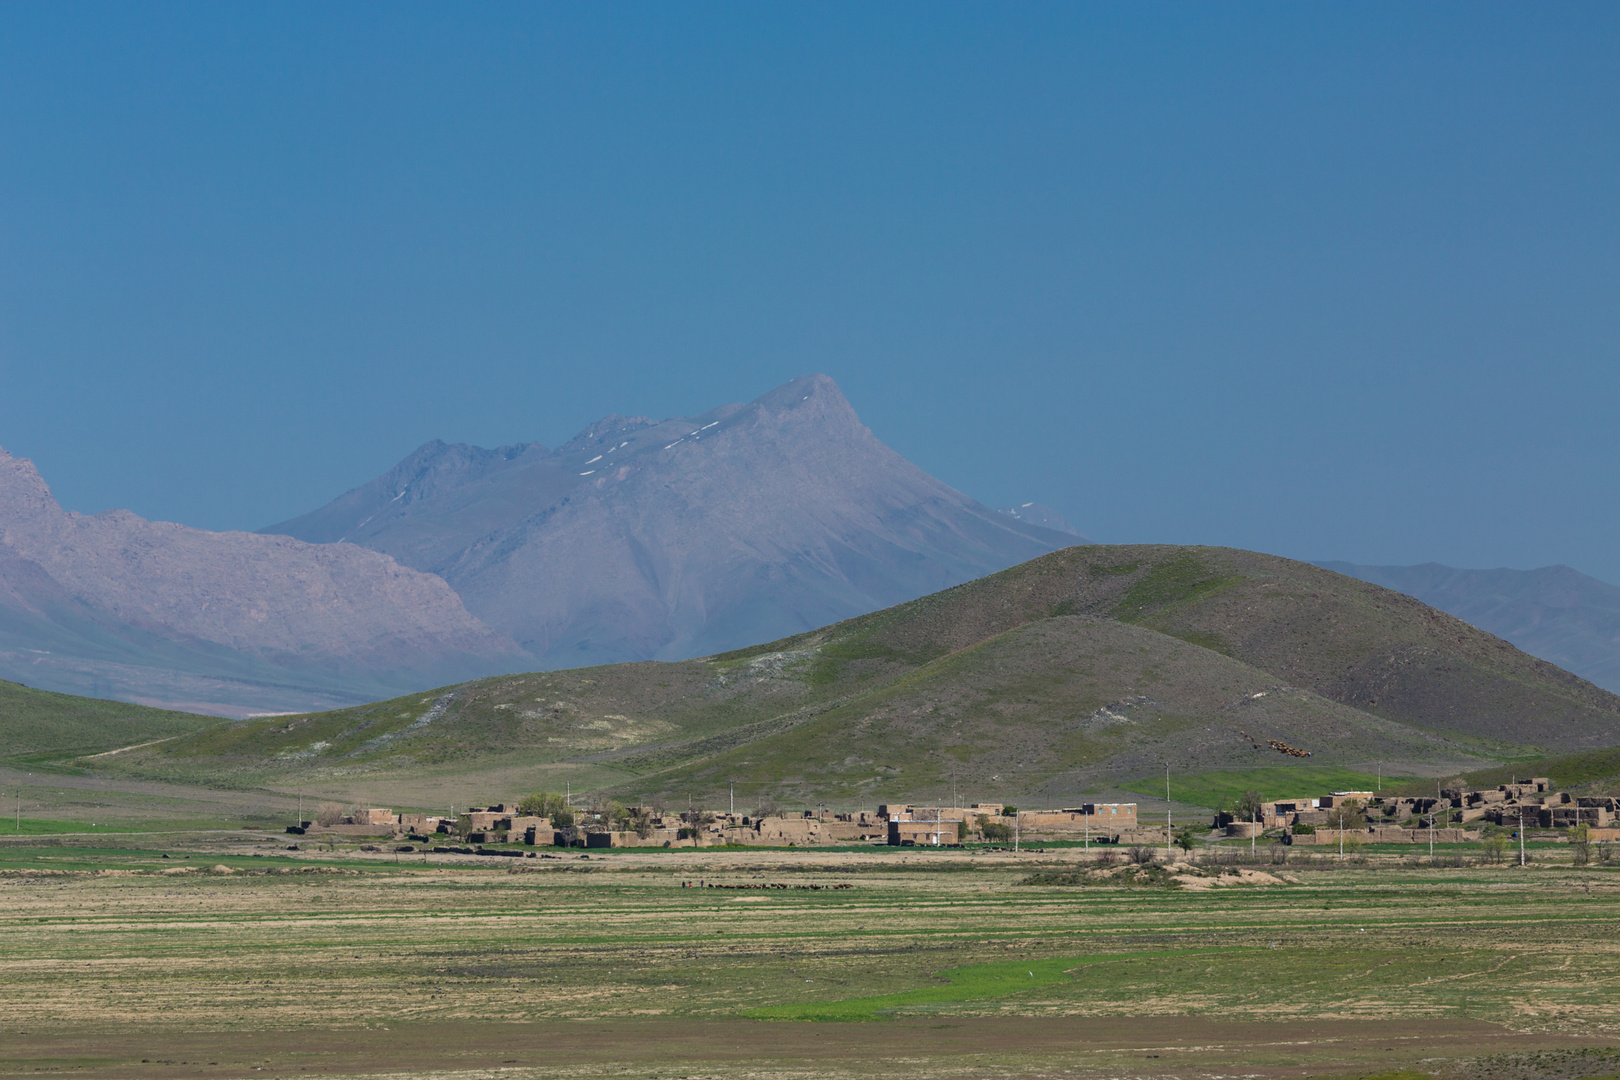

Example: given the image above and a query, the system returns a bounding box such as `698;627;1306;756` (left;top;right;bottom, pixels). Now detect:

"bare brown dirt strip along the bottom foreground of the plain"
0;1017;1605;1080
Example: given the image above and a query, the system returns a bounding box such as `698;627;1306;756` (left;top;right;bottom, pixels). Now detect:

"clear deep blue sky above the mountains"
0;2;1620;581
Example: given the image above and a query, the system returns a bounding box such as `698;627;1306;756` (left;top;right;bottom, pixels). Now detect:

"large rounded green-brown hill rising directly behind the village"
99;546;1620;805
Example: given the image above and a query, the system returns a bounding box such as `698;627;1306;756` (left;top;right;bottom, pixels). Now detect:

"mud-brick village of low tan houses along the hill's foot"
287;777;1620;852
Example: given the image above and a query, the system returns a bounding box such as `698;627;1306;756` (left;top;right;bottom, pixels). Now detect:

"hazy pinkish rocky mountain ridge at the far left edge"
0;450;527;716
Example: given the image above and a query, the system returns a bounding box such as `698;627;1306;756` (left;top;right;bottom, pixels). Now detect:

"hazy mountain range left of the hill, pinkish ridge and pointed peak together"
0;376;1084;717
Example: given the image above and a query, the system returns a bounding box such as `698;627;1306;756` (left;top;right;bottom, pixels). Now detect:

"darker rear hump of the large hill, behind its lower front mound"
737;546;1620;750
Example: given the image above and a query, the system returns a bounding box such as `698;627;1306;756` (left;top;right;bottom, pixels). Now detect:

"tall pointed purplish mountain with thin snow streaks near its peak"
266;376;1076;667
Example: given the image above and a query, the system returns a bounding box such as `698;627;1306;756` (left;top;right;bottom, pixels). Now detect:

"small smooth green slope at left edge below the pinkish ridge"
0;680;220;764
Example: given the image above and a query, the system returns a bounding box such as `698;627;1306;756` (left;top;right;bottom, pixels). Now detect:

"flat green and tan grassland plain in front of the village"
0;836;1620;1080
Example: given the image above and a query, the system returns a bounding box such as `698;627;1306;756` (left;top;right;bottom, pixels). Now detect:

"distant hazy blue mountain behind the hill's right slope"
1317;562;1620;693
